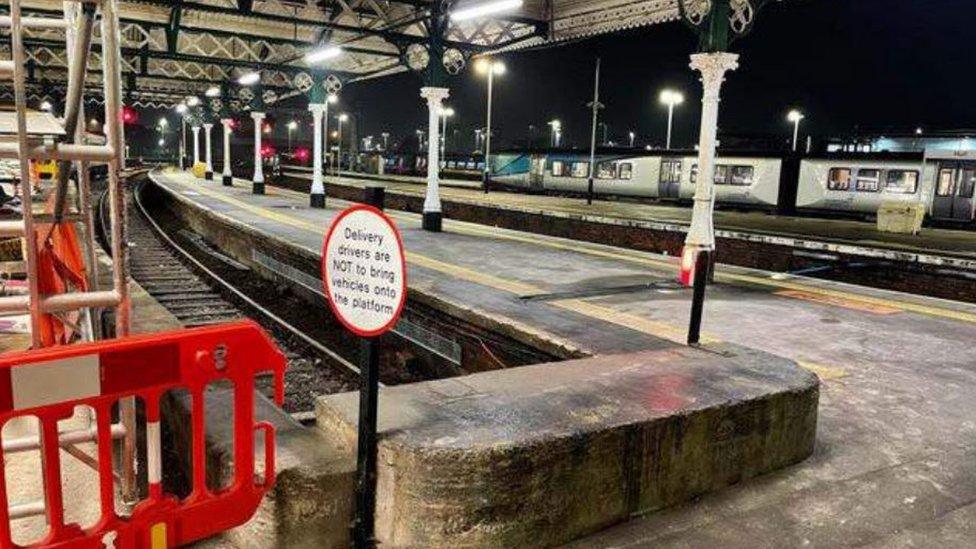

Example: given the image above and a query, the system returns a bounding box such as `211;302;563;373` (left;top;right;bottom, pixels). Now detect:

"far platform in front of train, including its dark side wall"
283;169;976;301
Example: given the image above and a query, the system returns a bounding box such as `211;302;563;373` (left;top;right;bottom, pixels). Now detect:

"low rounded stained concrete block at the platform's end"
317;347;819;547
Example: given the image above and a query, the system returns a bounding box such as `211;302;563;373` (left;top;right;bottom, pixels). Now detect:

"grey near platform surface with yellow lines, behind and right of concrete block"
155;169;976;547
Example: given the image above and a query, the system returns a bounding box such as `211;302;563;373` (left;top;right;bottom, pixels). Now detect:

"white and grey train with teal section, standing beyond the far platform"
491;150;976;223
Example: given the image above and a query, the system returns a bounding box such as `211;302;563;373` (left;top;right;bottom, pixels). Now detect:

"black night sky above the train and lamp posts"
342;0;976;150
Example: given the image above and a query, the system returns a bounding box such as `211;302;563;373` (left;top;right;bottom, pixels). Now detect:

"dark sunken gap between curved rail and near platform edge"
140;182;564;392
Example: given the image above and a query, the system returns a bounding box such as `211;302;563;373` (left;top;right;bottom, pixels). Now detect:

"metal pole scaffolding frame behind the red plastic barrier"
0;0;138;518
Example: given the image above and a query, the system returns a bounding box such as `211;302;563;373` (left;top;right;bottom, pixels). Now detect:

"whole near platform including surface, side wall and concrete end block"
152;172;976;547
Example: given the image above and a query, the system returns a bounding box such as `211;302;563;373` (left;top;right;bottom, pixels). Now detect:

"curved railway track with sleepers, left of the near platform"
98;178;358;414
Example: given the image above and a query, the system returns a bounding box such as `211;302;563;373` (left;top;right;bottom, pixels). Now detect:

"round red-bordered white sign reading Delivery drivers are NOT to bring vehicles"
322;204;407;337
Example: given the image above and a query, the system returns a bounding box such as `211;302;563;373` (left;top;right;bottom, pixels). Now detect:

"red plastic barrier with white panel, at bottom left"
0;322;286;549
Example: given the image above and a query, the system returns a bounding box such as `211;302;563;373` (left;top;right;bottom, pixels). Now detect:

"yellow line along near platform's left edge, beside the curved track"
172;179;720;344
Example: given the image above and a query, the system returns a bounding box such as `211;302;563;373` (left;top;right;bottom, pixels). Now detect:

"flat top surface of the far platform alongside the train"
285;170;976;259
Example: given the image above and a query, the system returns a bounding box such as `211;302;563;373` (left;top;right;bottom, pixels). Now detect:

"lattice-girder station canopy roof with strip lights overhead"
0;0;702;107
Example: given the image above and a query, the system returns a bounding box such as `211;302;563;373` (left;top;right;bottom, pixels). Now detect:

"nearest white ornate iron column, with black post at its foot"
677;0;771;345
